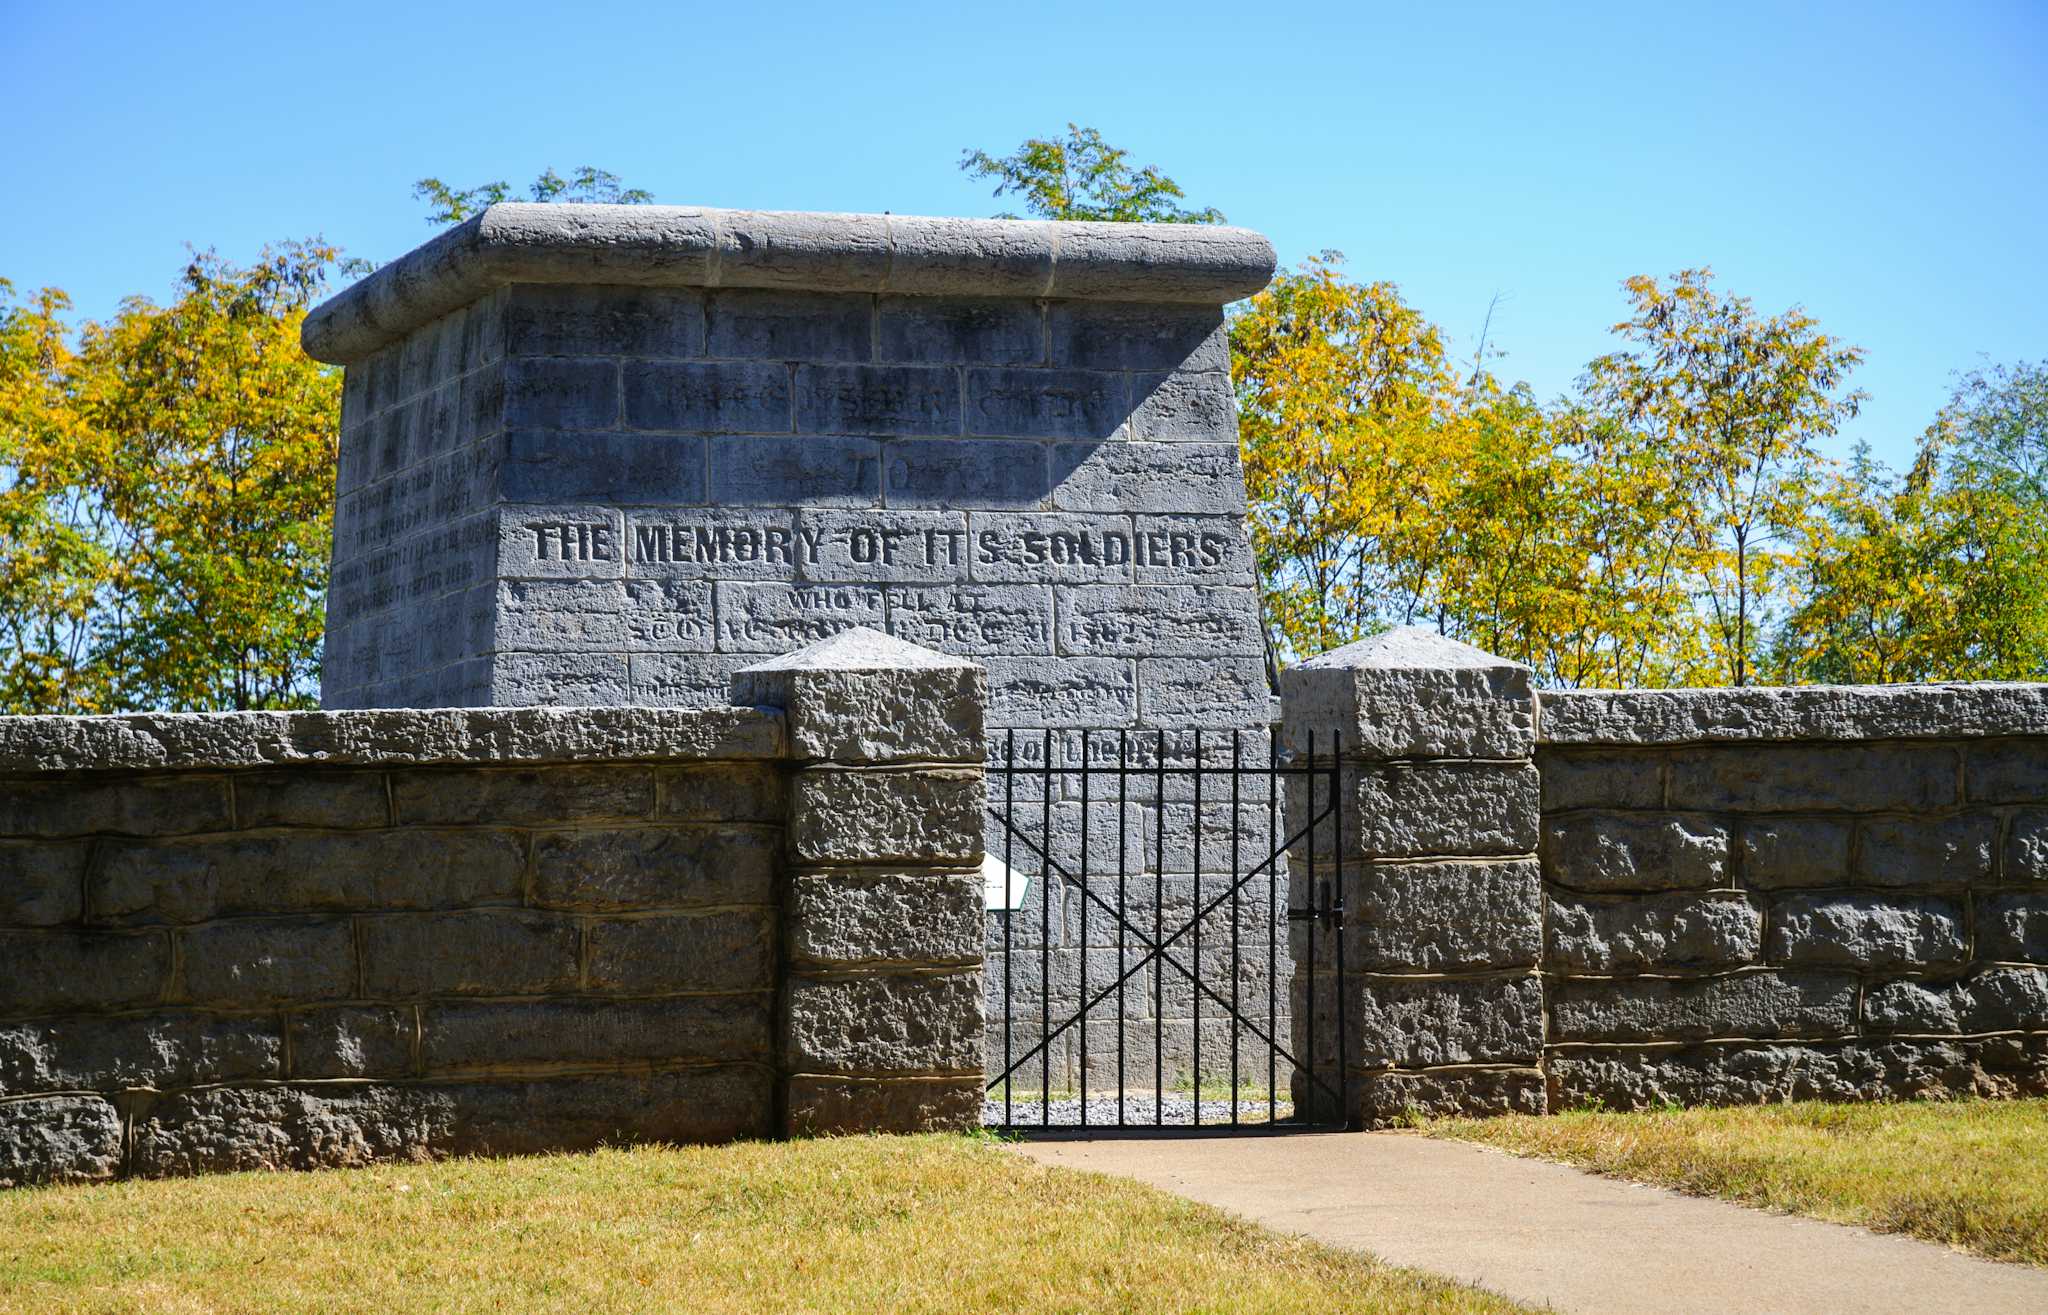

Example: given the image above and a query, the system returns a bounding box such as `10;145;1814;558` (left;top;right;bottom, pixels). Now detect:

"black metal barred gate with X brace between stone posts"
983;729;1348;1131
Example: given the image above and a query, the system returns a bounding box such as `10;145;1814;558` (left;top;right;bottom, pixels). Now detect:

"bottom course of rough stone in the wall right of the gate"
1548;1041;2048;1110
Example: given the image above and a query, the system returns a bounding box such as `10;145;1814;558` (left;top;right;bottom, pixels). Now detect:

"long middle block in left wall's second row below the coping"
88;832;526;922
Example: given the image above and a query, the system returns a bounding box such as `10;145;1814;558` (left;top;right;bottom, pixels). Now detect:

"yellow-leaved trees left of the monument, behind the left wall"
0;242;344;713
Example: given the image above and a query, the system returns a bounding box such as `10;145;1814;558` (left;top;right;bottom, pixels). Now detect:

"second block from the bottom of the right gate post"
1343;977;1544;1069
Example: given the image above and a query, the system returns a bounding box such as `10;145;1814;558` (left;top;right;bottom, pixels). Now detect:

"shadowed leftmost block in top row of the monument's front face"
503;283;705;356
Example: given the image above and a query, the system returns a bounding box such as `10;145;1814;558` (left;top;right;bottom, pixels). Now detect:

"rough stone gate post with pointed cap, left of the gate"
733;629;987;1133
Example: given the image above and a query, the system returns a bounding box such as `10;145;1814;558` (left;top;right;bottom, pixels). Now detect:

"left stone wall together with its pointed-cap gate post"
0;622;985;1186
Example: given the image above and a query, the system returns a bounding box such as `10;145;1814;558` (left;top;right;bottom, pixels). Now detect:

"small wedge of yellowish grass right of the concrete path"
1425;1100;2048;1266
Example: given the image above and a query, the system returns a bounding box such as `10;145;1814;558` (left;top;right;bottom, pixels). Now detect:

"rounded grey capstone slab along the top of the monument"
301;203;1276;365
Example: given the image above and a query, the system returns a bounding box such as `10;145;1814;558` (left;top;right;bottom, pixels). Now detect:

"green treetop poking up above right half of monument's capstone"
961;123;1223;223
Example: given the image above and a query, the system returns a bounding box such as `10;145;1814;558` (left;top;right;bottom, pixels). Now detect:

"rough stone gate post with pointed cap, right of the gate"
1280;629;1544;1127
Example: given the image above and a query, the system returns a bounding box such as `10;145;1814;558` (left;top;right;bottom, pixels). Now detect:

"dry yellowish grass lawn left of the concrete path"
0;1137;1520;1315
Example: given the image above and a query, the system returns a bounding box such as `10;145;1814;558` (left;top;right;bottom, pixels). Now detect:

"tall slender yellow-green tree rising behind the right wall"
1581;268;1864;684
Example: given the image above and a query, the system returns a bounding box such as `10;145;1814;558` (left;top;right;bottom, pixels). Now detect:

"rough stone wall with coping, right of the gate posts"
1536;684;2048;1106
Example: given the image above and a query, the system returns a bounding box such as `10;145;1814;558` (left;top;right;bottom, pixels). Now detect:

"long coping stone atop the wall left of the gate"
0;707;786;772
